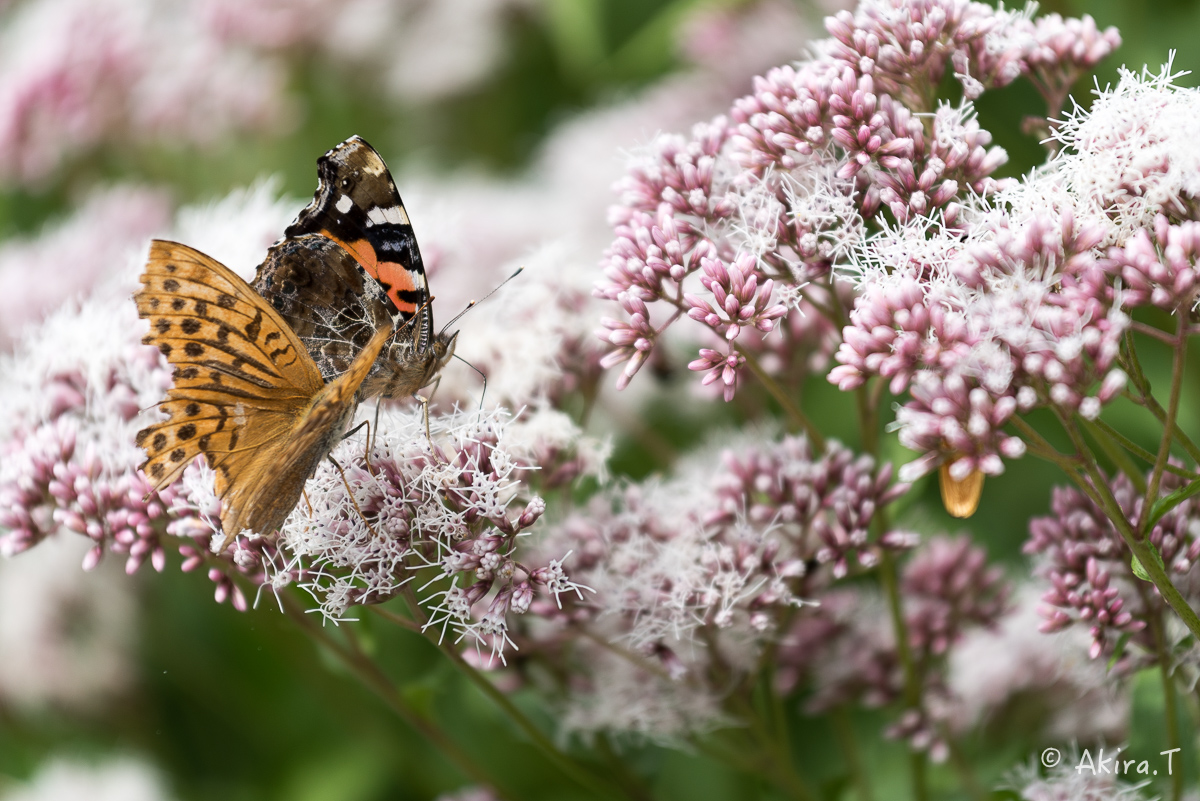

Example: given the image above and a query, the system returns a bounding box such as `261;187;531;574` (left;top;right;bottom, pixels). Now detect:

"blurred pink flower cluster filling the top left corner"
0;0;288;185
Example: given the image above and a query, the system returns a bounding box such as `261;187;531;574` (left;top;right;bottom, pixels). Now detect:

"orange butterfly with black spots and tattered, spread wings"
134;240;392;552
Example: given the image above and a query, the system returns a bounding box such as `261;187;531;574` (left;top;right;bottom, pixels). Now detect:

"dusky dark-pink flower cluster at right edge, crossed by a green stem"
1025;474;1200;658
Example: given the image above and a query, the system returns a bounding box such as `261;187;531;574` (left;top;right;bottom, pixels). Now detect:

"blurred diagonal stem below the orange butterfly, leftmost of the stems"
278;592;506;797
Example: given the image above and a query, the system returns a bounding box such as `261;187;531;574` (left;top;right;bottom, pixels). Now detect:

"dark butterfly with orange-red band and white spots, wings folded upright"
254;137;457;398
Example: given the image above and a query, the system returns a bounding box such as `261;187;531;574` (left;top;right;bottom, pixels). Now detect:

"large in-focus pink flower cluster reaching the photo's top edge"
595;0;1120;400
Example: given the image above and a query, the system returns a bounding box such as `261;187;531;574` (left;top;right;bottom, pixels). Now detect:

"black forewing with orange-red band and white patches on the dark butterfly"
284;137;433;350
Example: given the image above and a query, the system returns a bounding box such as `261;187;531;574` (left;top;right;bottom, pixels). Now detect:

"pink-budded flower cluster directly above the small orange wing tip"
829;213;1129;480
